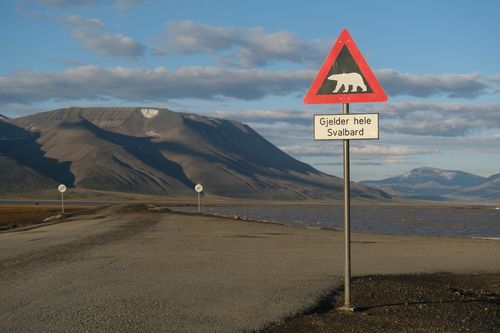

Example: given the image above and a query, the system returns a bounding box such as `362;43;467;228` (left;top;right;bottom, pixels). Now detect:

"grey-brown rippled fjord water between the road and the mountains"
169;205;500;238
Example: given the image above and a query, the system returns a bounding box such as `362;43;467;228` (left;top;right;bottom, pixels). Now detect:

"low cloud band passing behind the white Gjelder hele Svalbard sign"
214;102;500;137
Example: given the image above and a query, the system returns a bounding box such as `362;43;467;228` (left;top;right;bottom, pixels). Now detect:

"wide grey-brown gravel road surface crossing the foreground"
0;205;500;332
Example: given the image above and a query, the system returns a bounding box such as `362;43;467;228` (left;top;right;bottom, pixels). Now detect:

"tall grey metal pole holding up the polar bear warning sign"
343;103;353;311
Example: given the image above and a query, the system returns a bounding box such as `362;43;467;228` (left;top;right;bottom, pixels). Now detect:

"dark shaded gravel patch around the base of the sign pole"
259;274;500;333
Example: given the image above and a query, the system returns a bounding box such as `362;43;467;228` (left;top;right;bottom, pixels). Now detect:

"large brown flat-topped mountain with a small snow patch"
0;107;388;199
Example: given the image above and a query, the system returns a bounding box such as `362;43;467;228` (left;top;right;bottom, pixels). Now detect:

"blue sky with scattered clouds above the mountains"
0;0;500;180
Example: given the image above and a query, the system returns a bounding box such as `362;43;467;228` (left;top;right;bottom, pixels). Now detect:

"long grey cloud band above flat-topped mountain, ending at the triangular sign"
0;65;311;104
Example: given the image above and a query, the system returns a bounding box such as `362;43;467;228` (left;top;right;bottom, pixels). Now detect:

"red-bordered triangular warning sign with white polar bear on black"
304;29;387;104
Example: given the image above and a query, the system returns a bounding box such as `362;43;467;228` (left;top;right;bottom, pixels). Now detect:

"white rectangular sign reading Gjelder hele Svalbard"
314;113;379;140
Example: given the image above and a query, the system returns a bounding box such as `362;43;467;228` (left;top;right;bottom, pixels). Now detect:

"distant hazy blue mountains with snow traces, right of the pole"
361;167;500;202
